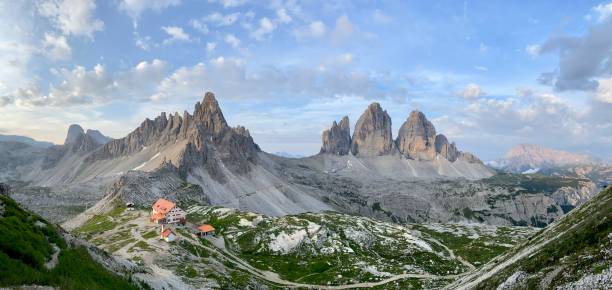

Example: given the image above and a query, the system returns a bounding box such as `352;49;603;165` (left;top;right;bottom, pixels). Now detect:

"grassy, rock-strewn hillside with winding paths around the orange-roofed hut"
73;203;537;289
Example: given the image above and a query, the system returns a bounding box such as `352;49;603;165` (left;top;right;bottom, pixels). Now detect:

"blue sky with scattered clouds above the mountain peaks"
0;0;612;160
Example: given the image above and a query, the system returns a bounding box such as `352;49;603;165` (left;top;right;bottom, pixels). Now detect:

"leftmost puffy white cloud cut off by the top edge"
38;0;104;38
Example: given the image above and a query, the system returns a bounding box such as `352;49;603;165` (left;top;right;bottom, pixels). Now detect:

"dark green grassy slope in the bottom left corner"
0;195;138;289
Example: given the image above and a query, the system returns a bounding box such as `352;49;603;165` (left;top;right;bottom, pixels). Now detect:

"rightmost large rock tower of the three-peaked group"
395;111;438;160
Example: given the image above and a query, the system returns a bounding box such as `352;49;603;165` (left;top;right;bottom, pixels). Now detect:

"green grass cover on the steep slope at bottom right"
478;188;612;289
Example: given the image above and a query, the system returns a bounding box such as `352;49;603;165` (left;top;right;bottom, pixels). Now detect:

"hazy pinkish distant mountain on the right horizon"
488;144;597;173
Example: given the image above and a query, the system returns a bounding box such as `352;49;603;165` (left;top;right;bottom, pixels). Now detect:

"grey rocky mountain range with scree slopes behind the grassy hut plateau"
2;93;596;226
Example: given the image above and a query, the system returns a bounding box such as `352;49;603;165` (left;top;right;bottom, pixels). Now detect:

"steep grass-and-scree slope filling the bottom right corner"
448;188;612;289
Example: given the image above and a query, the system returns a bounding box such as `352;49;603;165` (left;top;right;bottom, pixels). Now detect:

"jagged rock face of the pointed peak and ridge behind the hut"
87;92;260;181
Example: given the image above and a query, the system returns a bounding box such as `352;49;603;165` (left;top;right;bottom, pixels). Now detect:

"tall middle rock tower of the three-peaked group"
351;103;396;156
